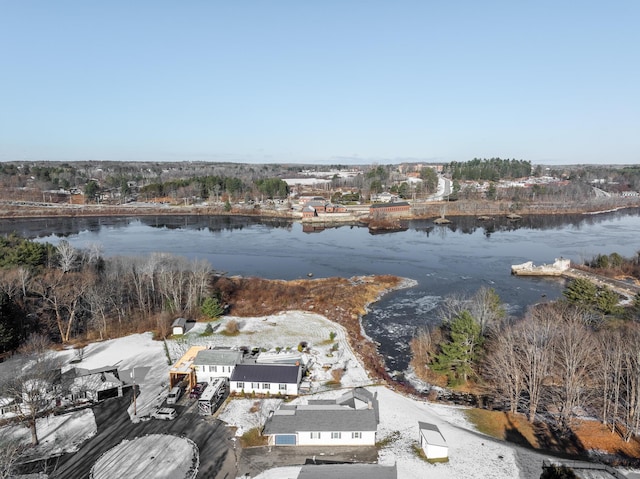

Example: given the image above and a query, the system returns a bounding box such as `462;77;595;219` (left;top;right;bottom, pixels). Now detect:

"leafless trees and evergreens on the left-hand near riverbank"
0;234;218;351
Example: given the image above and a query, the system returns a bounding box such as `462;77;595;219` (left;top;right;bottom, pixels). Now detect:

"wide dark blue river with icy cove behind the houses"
0;209;640;371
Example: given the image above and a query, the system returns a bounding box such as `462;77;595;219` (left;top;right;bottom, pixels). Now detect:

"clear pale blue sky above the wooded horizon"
0;0;640;164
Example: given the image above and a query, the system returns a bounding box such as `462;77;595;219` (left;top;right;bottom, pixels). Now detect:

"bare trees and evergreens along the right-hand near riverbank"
412;253;640;454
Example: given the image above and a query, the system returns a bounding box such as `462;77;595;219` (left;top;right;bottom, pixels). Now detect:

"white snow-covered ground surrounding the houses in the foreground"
0;312;540;479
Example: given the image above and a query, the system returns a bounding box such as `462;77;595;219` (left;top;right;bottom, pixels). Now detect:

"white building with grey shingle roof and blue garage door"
263;388;379;446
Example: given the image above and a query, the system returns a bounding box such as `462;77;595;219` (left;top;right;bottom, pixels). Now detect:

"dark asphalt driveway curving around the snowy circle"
50;397;236;479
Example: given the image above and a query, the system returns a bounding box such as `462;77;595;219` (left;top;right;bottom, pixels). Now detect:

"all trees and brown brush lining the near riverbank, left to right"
0;227;640;464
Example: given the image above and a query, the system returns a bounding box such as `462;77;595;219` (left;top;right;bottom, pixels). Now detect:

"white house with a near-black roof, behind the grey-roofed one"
229;364;302;396
